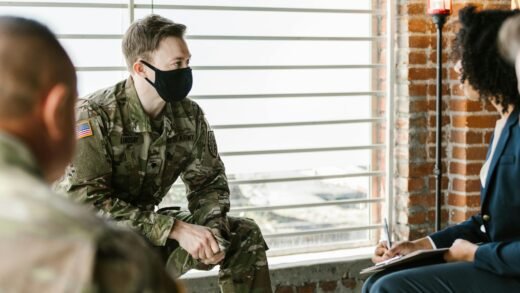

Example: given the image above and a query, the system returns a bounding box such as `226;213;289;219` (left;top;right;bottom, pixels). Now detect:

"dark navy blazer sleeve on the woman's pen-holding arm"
430;215;489;248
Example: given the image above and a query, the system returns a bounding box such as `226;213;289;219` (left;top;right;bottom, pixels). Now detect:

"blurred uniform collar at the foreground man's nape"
0;131;43;179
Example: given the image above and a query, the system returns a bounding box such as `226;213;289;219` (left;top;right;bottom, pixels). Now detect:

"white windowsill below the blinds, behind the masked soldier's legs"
181;246;374;279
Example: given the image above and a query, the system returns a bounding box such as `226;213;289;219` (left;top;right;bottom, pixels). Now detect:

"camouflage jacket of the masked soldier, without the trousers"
56;77;229;245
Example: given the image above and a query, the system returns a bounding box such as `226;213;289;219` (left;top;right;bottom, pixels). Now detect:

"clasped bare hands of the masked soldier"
170;220;220;261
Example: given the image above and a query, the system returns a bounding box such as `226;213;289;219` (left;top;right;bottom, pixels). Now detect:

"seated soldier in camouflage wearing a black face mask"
56;15;271;292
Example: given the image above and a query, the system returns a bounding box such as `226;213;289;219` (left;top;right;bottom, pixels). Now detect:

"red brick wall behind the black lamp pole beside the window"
394;0;511;239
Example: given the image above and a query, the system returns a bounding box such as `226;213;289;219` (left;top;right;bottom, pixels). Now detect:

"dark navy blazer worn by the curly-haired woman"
430;109;520;276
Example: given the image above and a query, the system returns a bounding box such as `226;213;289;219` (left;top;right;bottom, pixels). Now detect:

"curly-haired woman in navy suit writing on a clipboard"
363;6;520;292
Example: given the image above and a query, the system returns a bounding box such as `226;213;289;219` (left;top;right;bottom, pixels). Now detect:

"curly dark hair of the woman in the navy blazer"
452;6;520;111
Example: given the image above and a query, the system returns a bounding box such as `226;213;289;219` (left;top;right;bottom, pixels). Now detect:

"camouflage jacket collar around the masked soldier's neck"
125;76;173;133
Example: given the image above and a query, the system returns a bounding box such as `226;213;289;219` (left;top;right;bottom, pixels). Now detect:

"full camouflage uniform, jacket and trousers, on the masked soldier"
56;77;271;292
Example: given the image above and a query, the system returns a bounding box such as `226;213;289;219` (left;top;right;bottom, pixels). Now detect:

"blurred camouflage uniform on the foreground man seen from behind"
0;132;177;293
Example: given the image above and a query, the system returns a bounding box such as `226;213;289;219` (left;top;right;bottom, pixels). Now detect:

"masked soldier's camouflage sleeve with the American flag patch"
55;104;174;246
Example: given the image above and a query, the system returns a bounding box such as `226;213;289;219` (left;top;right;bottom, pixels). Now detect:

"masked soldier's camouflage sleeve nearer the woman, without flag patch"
181;109;230;239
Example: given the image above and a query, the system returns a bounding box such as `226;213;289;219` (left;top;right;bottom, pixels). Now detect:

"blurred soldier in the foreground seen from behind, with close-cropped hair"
0;16;177;293
